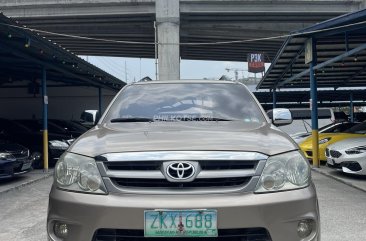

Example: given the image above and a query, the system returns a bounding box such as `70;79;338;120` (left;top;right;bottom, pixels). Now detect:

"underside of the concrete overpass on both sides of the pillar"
0;0;366;62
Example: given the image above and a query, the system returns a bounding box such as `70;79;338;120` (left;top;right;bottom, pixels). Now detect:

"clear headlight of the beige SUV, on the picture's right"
255;151;310;193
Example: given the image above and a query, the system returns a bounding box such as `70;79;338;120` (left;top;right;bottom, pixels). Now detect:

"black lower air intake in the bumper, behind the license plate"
93;228;271;241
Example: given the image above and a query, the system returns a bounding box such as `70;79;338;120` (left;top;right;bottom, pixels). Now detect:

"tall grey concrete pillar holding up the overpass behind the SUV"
155;0;180;80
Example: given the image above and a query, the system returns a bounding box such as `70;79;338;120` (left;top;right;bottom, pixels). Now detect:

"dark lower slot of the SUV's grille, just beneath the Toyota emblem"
111;177;250;188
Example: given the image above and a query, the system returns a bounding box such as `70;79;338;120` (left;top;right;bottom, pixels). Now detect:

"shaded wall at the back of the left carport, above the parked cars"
0;83;116;120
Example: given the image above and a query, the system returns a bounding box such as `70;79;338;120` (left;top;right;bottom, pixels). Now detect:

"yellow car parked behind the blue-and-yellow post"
299;133;365;161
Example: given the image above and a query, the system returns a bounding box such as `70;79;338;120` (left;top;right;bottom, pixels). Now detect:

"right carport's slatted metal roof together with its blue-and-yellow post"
257;9;366;166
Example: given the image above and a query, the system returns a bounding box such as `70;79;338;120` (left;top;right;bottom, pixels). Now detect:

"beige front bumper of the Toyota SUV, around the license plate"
47;184;320;241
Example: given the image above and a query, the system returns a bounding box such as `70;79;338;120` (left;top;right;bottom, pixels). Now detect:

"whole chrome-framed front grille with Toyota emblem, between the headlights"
97;151;268;193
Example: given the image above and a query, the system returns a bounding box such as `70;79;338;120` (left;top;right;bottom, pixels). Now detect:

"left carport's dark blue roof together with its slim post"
0;14;125;171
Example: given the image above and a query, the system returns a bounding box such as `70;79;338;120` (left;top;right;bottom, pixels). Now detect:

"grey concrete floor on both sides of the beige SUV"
0;172;366;241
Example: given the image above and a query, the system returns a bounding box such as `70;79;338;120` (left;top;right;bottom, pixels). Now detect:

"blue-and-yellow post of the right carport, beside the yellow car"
310;39;320;167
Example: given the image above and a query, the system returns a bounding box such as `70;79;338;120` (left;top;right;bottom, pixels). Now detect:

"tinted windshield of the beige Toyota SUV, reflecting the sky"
104;83;265;123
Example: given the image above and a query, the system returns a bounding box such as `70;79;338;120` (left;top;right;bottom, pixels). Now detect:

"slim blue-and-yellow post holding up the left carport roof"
42;67;48;172
